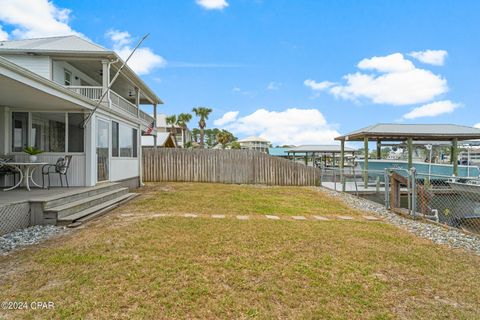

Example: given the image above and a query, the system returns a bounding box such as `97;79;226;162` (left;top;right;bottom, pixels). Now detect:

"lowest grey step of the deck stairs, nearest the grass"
57;193;138;227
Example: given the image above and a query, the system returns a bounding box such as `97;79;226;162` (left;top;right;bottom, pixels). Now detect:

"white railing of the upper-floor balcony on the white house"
66;86;155;124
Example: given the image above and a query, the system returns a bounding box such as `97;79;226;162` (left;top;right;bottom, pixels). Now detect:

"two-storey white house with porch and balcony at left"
0;36;162;186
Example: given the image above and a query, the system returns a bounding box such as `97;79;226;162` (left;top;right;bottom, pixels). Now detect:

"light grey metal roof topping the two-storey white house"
0;35;112;53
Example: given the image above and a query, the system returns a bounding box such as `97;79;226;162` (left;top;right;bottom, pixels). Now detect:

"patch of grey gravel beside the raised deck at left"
0;225;65;255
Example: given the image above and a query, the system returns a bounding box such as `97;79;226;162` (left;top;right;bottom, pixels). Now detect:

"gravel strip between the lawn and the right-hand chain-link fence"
319;188;480;255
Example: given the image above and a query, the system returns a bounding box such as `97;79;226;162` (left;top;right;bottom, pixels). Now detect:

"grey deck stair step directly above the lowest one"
44;187;128;219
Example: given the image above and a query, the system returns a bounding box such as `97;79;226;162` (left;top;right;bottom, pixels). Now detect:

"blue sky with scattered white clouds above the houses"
0;0;480;145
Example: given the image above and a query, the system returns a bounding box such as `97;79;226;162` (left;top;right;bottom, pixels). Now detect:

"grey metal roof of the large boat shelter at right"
335;123;480;141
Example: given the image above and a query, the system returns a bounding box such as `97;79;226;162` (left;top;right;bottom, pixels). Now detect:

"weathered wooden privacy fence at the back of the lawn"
143;148;320;186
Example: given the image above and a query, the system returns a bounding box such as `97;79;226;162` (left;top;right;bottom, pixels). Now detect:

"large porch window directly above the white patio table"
30;112;66;152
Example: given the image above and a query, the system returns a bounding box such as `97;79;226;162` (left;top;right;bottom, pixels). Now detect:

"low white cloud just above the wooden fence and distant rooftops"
219;108;340;145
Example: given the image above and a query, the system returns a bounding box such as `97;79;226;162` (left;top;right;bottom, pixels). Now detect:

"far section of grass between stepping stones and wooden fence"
131;183;360;216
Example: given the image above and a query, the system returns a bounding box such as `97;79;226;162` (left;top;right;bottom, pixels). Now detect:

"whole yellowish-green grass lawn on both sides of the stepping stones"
0;183;480;319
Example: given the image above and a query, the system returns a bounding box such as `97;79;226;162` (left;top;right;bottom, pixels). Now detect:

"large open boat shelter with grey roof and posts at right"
335;123;480;183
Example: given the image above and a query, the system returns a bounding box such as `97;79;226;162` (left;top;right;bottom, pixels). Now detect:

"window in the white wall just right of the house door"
112;121;138;158
